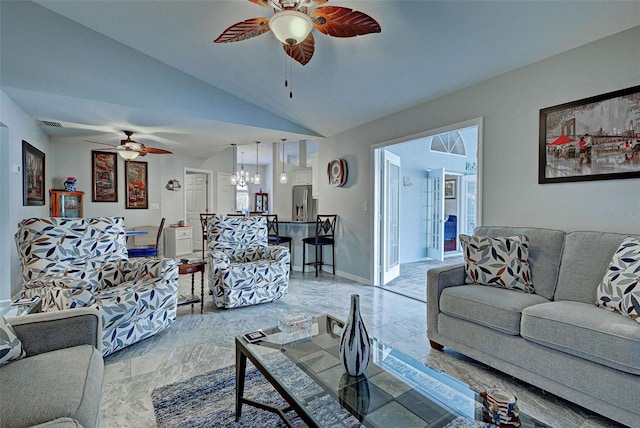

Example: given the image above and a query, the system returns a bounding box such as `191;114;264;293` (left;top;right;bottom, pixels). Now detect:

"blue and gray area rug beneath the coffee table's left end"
151;364;298;428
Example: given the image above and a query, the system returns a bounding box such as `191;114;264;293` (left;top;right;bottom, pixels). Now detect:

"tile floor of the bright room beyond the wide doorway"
383;251;464;302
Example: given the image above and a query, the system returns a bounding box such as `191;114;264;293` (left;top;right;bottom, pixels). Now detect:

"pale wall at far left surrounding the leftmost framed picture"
0;91;52;300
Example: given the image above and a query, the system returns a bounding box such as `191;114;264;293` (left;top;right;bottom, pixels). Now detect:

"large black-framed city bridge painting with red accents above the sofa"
538;86;640;184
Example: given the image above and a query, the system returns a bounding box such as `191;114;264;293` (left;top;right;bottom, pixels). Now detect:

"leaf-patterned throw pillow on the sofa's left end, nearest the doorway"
460;235;534;293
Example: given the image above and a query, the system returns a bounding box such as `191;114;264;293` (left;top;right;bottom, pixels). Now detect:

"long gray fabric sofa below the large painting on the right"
427;226;640;426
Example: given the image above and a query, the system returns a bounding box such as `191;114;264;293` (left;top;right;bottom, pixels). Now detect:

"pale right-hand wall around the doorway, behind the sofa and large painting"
319;26;640;280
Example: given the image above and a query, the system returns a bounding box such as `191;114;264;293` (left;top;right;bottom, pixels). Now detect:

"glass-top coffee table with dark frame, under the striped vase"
235;315;546;428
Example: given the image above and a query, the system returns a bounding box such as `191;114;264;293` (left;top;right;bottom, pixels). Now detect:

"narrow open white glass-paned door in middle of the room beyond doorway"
427;168;444;261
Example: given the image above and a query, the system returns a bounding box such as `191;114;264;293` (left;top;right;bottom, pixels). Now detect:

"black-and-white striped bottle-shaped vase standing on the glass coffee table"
340;294;371;376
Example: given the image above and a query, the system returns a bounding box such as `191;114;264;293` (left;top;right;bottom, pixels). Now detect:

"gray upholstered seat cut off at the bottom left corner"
0;308;104;428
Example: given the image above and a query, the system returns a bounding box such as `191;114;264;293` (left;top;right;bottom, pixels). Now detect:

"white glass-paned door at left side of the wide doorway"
380;150;401;285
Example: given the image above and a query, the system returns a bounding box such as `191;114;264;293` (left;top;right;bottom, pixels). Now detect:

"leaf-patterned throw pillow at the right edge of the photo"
596;236;640;322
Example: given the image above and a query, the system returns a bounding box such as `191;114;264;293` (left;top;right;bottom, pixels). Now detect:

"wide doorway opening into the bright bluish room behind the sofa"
372;118;482;301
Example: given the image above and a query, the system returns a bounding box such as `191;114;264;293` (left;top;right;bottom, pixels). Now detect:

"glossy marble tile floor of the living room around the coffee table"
100;272;617;428
